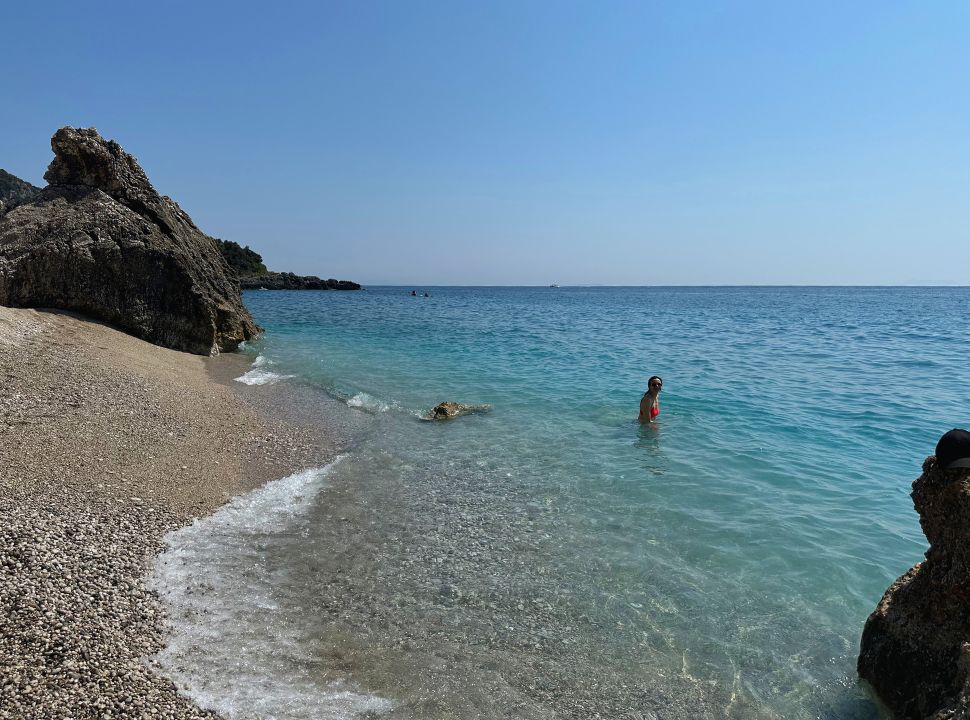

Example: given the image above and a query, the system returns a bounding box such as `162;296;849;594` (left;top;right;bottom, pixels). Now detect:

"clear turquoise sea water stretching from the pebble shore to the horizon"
151;288;970;719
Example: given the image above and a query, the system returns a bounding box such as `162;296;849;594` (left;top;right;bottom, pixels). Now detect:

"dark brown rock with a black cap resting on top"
858;457;970;720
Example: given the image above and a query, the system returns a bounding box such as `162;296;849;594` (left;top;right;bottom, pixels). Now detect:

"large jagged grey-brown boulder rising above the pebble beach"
0;128;259;355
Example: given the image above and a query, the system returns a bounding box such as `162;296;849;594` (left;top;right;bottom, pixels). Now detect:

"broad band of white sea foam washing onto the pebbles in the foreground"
149;457;392;720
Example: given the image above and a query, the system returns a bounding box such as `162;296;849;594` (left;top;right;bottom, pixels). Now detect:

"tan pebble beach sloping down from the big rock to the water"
0;307;337;719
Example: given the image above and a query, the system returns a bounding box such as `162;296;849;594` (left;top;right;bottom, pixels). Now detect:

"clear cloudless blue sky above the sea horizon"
0;0;970;286
